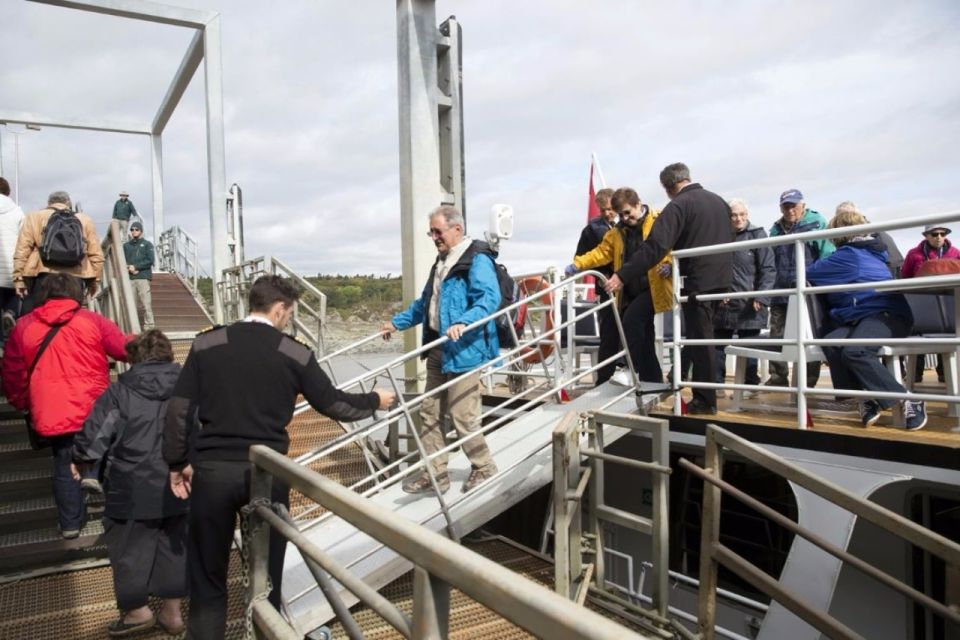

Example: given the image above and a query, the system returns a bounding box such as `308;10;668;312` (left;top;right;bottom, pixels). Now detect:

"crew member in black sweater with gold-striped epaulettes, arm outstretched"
163;276;396;640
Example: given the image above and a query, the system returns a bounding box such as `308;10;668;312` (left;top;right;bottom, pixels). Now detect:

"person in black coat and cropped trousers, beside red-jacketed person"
73;329;189;637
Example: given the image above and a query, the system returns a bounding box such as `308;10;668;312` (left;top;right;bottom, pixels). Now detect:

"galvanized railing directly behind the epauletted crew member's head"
217;256;327;355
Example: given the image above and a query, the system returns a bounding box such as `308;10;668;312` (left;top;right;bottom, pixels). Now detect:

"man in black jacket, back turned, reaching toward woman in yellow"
606;162;733;414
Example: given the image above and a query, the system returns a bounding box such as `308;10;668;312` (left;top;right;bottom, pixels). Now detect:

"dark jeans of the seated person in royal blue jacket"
823;313;912;409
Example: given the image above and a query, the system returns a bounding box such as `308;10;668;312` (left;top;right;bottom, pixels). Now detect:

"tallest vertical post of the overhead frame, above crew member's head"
203;15;229;324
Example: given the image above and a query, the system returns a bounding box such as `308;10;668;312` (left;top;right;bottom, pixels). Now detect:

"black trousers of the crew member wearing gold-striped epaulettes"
187;461;290;640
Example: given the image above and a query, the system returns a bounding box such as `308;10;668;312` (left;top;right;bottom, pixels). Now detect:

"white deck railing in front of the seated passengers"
665;211;960;429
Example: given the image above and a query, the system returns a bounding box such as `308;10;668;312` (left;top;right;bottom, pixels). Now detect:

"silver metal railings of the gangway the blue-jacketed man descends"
288;272;636;603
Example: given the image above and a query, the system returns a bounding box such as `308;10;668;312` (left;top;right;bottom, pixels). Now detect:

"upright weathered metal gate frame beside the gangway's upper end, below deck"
553;411;671;624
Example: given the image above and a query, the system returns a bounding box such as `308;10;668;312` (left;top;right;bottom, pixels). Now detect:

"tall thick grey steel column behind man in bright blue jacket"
397;0;441;393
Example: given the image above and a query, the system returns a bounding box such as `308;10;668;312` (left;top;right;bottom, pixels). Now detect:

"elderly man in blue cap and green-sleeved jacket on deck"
765;189;836;387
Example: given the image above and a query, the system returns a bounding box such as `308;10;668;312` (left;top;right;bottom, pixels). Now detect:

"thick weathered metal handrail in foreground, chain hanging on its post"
249;445;643;640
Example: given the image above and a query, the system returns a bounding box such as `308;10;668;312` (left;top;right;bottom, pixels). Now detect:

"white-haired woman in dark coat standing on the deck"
713;199;777;390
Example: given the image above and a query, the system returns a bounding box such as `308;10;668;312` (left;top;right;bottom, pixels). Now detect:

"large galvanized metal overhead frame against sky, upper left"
8;0;228;322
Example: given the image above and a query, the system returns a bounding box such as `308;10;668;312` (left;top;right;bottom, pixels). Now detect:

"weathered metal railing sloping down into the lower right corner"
680;424;960;640
